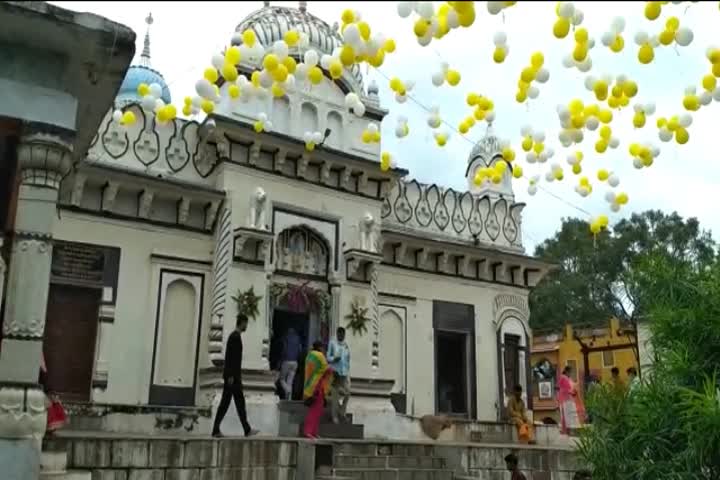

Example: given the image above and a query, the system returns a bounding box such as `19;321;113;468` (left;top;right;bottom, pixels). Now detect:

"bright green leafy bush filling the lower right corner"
580;253;720;480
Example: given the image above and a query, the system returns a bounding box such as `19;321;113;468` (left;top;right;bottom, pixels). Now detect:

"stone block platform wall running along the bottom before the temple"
42;432;579;480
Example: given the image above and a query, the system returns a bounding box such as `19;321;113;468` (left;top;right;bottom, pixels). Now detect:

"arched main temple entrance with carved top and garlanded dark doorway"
268;225;330;400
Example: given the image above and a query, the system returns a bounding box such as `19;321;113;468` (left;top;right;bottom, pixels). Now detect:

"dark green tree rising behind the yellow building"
530;210;715;329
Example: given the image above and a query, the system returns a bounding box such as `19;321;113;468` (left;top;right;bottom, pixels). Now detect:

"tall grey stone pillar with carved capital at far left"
0;133;72;448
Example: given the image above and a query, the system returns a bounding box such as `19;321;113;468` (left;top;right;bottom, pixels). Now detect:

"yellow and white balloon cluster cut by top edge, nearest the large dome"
397;2;478;47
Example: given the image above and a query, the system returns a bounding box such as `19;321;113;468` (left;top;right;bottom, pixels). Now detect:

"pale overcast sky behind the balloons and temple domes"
50;1;720;252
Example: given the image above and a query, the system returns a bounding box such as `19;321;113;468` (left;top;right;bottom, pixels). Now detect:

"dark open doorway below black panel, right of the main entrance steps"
435;331;469;416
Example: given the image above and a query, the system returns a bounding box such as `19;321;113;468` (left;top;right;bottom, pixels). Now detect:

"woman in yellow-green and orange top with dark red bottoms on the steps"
303;341;332;439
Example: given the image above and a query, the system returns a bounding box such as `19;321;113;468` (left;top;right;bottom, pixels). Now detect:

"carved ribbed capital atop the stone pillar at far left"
17;133;73;189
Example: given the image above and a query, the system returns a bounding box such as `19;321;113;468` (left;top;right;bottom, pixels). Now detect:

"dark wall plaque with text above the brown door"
51;241;105;285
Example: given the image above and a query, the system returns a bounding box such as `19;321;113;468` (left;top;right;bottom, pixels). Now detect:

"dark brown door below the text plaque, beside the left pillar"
43;283;100;402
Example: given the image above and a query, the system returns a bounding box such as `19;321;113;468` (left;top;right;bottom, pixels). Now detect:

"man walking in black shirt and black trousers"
212;314;258;437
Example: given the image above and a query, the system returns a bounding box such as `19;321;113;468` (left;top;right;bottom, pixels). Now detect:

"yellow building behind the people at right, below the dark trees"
530;318;637;423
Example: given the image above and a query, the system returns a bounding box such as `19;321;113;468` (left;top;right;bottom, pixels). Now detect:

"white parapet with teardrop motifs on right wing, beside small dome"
382;180;525;251
